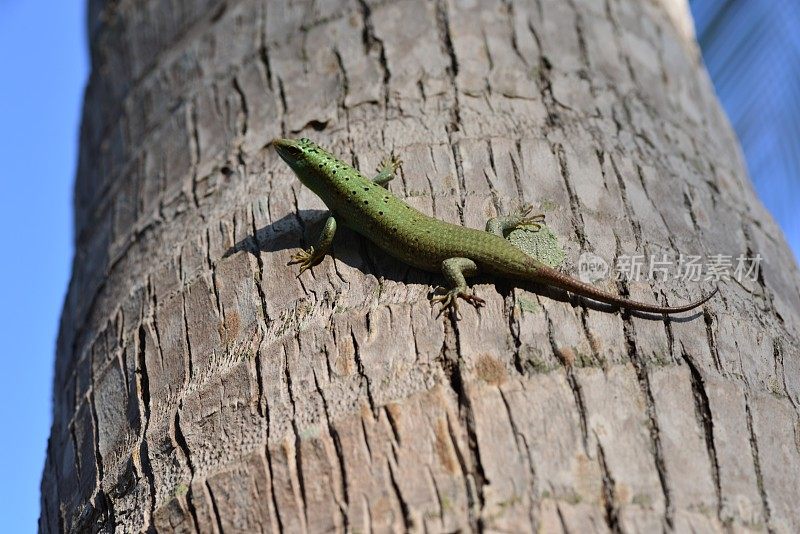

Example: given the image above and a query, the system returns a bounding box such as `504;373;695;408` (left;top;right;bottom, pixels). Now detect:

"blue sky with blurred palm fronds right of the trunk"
691;0;800;259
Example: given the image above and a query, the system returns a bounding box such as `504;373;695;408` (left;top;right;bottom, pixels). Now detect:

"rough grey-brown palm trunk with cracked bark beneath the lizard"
40;0;800;532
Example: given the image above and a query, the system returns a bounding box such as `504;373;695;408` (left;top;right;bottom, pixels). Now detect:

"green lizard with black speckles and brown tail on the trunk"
272;138;717;314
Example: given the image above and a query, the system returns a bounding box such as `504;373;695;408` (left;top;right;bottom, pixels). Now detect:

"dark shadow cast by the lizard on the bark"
223;210;703;323
